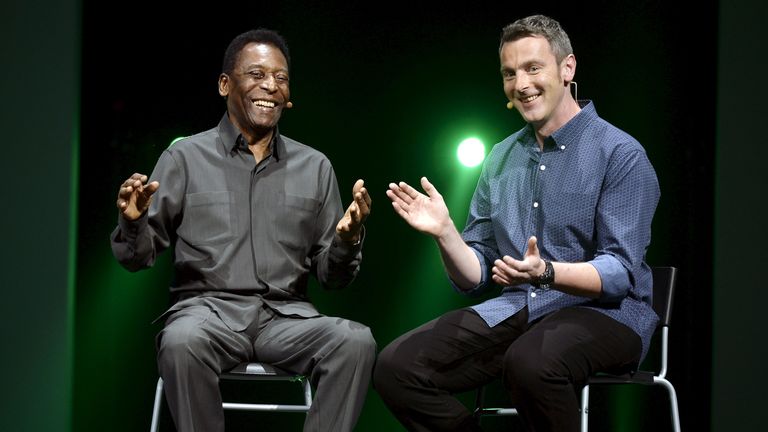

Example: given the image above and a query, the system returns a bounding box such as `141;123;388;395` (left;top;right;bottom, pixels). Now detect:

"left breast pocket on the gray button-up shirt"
178;191;237;245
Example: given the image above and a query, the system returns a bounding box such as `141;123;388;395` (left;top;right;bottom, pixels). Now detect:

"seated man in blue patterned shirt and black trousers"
374;15;659;432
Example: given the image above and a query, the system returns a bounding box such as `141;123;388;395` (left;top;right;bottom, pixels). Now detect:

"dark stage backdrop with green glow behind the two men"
0;0;768;431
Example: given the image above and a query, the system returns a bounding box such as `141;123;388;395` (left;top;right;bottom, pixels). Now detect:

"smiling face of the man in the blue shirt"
499;36;578;135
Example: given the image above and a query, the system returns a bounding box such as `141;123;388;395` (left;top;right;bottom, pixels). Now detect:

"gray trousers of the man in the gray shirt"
158;296;376;432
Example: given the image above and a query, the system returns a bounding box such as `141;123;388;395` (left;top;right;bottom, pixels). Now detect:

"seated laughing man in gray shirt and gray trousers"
112;29;376;432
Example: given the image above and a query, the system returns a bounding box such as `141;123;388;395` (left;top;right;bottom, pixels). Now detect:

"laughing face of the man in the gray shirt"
219;43;291;141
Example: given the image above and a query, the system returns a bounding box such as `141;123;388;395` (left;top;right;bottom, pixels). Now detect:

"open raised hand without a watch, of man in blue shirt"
387;177;455;237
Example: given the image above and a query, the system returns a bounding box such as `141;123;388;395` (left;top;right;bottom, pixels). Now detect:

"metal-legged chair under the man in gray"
150;363;312;432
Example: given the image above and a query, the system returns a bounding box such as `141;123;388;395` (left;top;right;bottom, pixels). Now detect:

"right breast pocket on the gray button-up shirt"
273;195;320;250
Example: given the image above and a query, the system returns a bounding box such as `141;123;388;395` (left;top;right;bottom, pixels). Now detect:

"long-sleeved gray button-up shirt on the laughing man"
112;114;362;316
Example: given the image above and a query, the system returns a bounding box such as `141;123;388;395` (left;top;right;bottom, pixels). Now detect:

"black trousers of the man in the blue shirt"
373;307;642;432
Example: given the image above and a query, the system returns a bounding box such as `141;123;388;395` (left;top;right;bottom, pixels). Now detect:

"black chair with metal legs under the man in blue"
475;267;680;432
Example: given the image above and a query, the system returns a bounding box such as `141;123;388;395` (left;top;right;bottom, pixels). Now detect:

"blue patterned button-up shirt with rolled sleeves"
462;101;660;357
